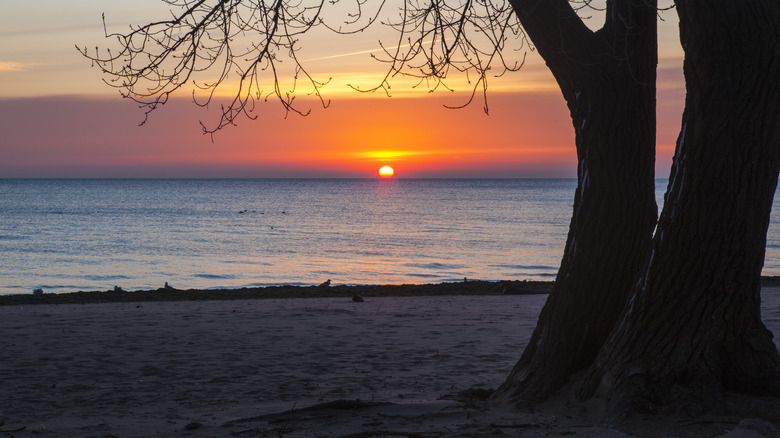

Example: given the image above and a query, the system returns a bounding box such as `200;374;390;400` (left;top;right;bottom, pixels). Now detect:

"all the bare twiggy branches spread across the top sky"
77;0;652;134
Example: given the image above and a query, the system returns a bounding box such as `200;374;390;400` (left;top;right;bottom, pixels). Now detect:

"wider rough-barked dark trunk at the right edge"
580;0;780;410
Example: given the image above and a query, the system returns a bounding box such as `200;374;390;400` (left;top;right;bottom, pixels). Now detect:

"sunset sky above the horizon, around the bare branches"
0;0;684;178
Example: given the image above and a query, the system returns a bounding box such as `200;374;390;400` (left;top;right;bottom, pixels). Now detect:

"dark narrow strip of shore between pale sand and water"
0;280;553;306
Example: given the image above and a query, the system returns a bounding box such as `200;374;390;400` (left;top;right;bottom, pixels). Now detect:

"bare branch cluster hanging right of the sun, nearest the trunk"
353;0;531;112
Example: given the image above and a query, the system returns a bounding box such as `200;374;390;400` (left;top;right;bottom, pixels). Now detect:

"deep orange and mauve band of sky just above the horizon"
0;84;676;177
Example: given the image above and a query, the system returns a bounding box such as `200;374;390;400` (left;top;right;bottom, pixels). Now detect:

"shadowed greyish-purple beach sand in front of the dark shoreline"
0;288;780;437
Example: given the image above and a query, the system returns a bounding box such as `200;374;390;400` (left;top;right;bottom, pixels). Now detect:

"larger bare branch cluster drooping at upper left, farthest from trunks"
79;0;360;134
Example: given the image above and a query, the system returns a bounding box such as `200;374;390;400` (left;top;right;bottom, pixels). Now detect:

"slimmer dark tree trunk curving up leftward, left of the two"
494;0;657;404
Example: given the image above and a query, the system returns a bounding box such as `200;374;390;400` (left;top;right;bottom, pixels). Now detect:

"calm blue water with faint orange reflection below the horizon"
0;179;780;294
